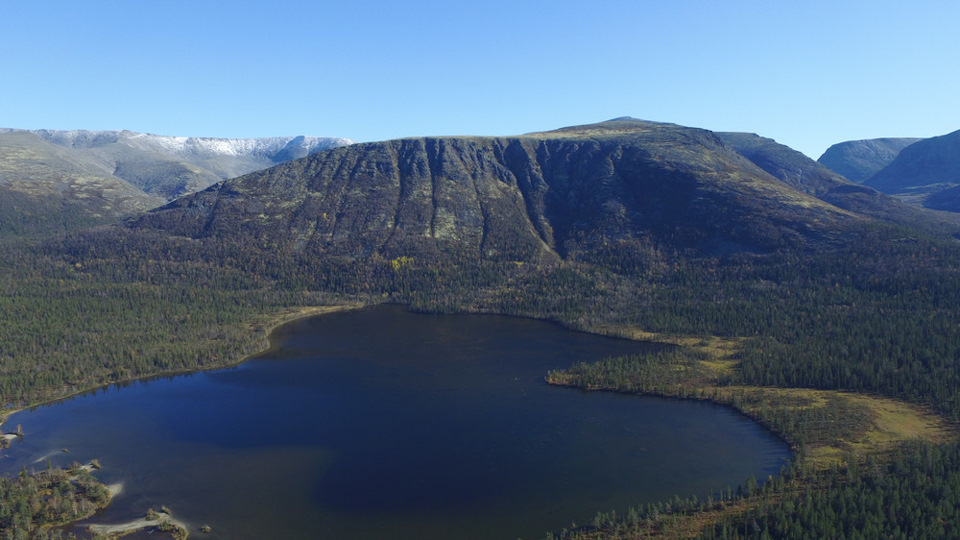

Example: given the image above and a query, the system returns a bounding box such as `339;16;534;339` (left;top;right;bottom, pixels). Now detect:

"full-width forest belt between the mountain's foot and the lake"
0;216;960;536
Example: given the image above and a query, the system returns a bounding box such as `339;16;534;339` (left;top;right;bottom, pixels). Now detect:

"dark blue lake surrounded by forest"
0;305;790;540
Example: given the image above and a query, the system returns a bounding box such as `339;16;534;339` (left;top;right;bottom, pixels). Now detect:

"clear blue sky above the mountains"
0;0;960;158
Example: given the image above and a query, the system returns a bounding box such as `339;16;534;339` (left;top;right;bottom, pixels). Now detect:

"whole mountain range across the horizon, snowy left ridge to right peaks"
7;121;960;244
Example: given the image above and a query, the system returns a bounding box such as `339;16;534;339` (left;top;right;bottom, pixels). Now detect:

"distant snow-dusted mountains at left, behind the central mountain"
0;129;353;234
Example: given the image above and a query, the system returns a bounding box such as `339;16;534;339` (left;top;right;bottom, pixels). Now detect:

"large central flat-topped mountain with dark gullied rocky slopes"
129;119;884;262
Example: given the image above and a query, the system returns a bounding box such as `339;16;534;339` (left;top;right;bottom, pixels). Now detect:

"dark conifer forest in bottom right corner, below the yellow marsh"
548;442;960;540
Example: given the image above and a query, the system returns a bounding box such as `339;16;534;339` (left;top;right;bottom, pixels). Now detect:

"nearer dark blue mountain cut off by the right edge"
864;131;960;212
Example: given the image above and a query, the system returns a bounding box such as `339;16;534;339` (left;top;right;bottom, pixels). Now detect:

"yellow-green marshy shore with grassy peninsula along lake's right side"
547;351;958;540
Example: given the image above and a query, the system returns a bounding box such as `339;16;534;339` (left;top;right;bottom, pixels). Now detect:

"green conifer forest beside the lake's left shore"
0;230;360;405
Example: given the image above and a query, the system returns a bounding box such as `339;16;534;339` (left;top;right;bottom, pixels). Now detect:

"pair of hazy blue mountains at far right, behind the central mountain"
819;131;960;212
